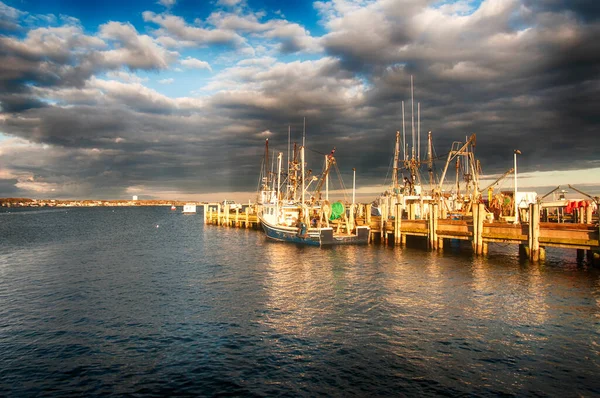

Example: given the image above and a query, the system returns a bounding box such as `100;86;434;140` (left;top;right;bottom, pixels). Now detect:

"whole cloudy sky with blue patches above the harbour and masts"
0;0;600;201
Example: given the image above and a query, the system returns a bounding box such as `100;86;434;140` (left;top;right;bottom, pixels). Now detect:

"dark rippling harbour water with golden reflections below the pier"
0;207;600;397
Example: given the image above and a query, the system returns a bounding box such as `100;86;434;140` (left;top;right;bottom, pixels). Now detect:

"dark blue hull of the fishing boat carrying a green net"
259;217;369;246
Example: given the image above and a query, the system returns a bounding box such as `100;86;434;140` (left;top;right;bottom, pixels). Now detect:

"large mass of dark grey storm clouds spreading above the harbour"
0;0;600;198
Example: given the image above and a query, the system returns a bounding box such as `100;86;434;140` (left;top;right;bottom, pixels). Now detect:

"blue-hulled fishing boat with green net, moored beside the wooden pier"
258;133;370;246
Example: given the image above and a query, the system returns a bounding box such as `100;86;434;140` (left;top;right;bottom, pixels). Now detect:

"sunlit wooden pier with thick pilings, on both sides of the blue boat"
204;203;600;263
